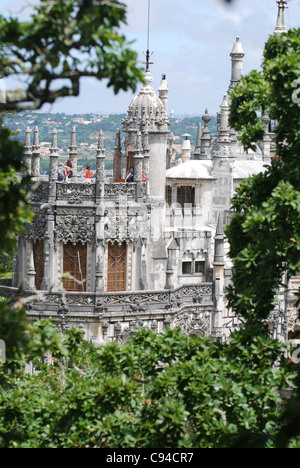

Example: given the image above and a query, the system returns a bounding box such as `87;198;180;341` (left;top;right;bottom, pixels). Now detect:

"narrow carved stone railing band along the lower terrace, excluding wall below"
0;283;213;317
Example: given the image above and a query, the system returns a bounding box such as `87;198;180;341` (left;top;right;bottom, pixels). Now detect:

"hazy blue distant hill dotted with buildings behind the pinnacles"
4;112;217;174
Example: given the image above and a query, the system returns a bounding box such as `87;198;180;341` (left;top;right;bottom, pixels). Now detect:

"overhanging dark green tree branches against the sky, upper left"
0;0;143;110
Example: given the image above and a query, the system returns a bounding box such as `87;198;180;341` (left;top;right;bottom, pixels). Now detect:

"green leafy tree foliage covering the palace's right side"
226;29;300;319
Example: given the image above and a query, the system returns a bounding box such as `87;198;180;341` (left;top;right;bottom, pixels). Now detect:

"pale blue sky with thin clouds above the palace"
0;0;300;115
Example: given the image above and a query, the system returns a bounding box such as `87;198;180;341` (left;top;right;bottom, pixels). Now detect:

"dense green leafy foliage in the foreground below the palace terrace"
0;324;292;448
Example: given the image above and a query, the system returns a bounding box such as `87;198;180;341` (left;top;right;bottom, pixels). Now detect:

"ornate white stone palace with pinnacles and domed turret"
0;2;299;345
